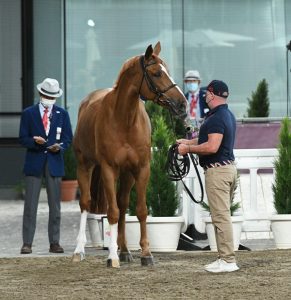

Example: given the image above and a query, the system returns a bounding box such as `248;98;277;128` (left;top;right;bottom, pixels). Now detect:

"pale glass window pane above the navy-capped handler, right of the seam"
184;0;290;117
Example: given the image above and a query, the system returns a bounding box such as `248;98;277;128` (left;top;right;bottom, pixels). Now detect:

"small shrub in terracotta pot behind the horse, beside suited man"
61;145;78;201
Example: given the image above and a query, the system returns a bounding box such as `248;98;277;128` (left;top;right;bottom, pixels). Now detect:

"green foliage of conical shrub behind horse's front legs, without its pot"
128;101;181;216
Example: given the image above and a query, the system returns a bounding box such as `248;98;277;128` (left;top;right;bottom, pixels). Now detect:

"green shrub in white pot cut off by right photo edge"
271;117;291;249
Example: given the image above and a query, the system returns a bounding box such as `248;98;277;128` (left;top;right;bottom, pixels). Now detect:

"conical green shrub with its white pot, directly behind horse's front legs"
126;113;184;252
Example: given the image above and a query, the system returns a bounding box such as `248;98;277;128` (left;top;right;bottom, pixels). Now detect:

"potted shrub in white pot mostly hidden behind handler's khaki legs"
201;174;244;251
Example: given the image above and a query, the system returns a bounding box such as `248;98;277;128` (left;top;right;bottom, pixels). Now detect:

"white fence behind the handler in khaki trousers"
180;149;278;238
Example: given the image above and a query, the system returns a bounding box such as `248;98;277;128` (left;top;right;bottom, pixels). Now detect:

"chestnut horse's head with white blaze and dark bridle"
140;42;187;120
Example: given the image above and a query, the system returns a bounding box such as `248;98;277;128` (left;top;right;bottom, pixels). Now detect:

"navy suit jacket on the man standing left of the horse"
19;104;73;177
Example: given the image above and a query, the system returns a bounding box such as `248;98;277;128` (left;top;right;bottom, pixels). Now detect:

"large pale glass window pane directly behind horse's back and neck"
66;0;183;129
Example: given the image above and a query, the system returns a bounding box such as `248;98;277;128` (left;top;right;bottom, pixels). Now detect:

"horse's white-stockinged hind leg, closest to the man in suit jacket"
72;160;93;262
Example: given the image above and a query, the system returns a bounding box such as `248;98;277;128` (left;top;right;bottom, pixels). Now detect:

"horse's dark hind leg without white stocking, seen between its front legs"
117;173;134;262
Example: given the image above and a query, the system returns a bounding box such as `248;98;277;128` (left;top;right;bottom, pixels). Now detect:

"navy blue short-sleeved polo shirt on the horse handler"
198;104;236;167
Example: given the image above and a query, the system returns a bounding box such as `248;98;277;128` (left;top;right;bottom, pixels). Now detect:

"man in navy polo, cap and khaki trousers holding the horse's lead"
177;80;239;273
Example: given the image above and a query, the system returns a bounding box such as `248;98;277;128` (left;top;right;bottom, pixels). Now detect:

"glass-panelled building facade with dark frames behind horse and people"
0;0;291;197
